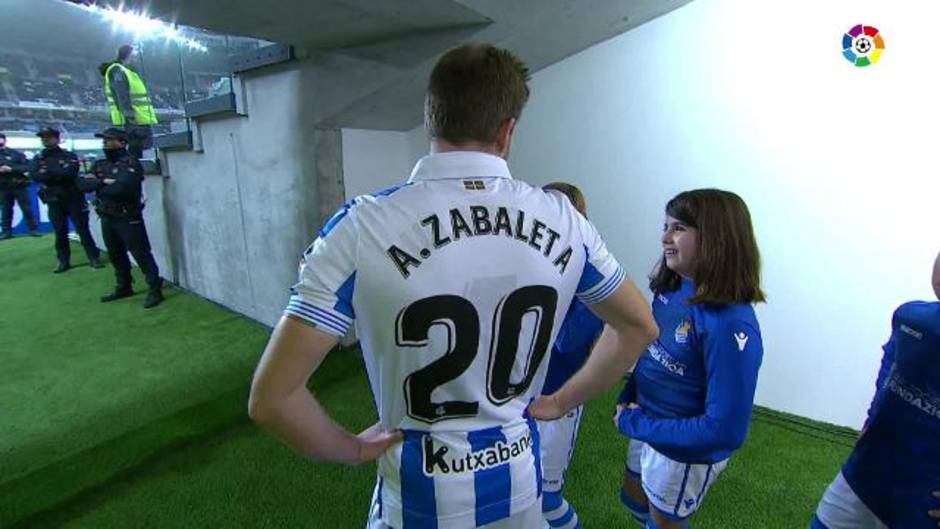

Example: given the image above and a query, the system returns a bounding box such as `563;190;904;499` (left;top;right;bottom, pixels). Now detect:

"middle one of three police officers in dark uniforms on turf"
29;127;104;274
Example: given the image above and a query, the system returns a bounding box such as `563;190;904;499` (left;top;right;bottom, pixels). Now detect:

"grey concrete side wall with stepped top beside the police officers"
147;68;342;325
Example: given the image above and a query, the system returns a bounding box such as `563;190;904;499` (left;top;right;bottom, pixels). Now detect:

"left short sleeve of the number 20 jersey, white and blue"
285;205;358;337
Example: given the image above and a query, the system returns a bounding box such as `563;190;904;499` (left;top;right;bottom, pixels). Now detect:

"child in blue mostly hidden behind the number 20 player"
538;182;604;529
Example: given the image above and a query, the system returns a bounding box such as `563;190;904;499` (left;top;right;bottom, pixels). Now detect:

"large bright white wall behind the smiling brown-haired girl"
510;0;940;427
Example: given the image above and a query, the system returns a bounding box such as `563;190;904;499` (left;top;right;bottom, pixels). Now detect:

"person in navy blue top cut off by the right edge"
811;251;940;529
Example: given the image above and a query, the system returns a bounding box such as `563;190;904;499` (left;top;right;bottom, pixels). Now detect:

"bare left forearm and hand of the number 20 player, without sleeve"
248;315;400;464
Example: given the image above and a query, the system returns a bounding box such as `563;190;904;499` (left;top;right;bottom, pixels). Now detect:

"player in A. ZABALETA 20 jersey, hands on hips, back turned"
249;44;656;529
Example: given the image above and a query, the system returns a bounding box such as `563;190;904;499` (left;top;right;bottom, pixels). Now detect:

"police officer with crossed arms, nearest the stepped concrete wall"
79;127;163;309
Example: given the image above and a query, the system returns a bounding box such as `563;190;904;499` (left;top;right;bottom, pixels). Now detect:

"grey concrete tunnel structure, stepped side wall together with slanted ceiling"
42;0;687;324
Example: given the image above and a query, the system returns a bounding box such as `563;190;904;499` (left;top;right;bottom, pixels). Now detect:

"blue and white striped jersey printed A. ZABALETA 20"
287;152;624;529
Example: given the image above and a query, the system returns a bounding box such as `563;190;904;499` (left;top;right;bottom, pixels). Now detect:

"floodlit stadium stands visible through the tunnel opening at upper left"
0;0;269;157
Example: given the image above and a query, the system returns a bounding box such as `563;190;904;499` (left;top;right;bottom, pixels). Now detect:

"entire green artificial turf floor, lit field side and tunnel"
0;237;852;529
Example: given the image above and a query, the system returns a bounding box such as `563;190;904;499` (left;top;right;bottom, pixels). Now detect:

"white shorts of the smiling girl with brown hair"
627;440;728;521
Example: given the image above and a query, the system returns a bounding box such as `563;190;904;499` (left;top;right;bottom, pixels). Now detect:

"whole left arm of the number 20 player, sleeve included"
248;204;401;463
